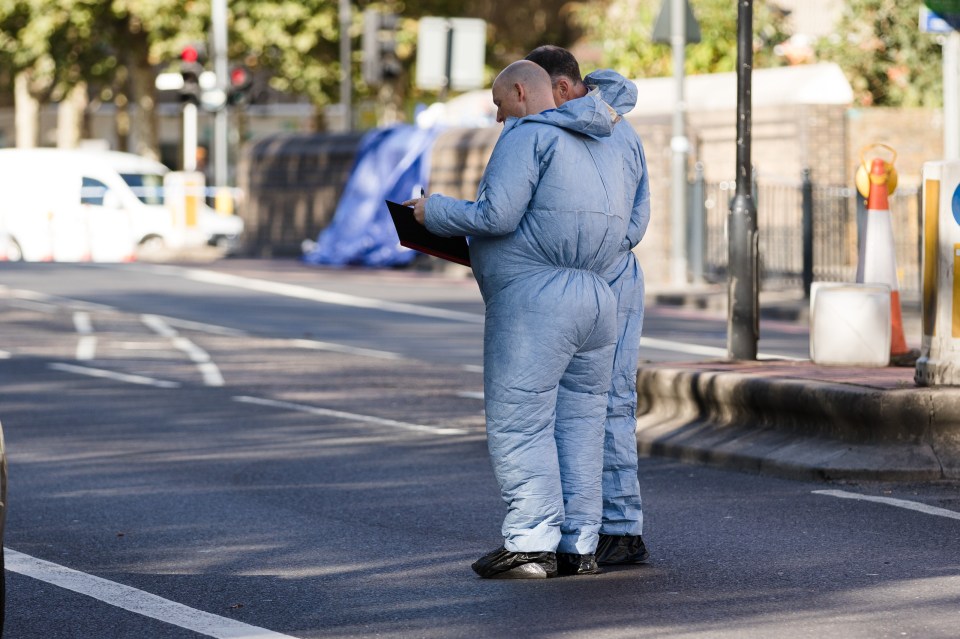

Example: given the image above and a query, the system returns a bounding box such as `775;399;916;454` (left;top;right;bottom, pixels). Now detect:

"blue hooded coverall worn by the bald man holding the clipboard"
425;91;629;554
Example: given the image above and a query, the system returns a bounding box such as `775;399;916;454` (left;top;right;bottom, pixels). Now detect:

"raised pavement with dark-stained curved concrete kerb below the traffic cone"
637;294;960;481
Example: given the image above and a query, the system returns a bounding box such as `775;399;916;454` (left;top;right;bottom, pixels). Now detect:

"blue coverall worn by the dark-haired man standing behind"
584;70;650;535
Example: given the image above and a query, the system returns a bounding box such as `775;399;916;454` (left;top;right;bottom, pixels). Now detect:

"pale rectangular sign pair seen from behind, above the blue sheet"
416;17;487;91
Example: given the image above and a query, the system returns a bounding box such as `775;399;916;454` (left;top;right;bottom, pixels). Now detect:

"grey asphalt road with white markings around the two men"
0;260;960;639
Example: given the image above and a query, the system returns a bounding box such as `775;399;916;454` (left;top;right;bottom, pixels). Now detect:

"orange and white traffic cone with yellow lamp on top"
857;158;910;362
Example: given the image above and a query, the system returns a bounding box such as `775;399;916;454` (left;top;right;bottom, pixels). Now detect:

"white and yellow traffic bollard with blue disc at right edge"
913;161;960;386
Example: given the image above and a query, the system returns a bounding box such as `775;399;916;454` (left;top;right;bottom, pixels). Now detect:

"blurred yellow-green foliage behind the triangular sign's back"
573;0;789;78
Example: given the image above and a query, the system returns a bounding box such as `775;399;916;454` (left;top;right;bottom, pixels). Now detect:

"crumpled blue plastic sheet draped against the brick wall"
303;125;439;266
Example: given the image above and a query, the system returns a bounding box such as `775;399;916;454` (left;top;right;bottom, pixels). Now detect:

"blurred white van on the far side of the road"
0;148;243;261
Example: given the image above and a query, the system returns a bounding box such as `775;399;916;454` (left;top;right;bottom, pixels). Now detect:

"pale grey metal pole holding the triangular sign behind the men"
670;0;690;285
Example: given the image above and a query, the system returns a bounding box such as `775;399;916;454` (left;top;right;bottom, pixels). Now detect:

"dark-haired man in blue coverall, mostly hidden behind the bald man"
526;45;650;565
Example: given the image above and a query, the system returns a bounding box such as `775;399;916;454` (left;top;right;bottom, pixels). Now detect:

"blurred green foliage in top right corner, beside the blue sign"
817;0;943;107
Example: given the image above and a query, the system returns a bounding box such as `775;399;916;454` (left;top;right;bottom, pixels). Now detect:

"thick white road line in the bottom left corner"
3;548;295;639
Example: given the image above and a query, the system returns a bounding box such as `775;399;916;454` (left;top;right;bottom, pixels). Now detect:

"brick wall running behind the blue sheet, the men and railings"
239;105;942;286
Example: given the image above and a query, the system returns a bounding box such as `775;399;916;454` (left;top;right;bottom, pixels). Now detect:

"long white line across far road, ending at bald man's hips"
142;266;483;324
